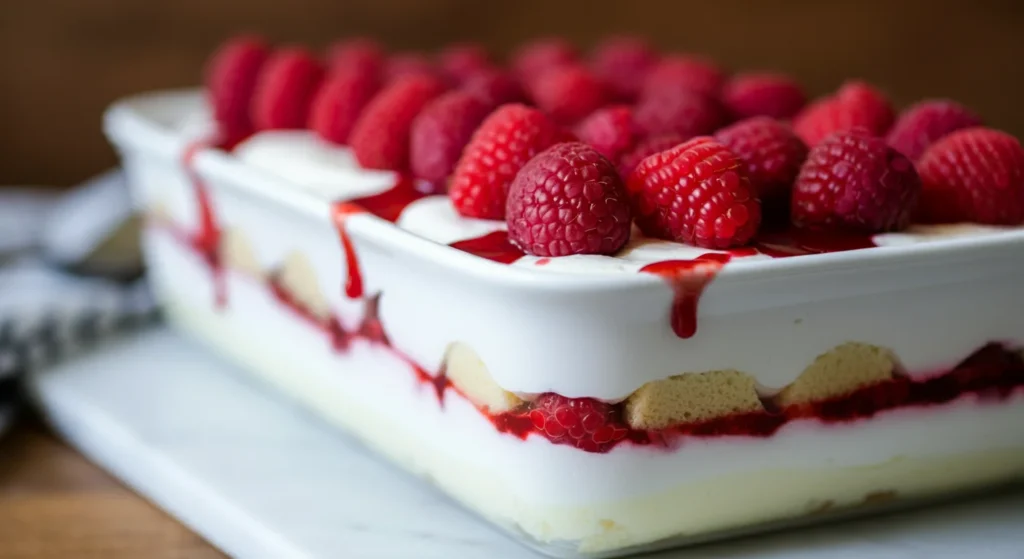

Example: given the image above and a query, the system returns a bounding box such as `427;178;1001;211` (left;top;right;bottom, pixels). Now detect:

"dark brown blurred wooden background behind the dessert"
0;0;1024;184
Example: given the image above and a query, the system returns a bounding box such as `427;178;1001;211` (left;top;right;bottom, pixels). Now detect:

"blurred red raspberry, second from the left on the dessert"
252;47;324;130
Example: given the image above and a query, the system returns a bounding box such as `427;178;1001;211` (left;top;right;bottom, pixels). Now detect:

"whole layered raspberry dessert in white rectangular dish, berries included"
106;38;1024;557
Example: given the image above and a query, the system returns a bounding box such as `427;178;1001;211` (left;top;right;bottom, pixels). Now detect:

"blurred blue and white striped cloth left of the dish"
0;173;157;431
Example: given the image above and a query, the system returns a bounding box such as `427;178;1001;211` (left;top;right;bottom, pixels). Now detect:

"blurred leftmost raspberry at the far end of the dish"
206;37;268;143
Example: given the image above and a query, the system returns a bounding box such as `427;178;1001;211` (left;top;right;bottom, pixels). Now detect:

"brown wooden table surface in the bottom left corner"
0;418;224;559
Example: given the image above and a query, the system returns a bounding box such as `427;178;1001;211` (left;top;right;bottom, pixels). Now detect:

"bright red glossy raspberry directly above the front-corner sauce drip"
627;136;761;249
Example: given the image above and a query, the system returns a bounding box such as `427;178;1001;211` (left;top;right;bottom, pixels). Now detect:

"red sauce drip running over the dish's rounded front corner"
640;253;732;339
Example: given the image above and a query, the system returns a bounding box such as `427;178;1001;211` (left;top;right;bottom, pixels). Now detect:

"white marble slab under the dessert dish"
24;328;1024;559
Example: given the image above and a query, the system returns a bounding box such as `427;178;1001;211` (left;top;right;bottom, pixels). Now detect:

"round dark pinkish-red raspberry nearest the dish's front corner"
505;142;632;256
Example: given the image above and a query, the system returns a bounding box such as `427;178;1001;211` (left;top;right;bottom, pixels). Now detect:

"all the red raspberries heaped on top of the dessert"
206;37;1024;256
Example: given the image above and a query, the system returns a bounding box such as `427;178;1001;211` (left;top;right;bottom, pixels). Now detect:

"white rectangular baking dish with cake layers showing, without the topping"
105;91;1024;557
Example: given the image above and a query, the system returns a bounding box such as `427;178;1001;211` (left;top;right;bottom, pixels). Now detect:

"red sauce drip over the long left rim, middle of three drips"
331;177;426;299
